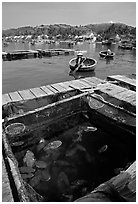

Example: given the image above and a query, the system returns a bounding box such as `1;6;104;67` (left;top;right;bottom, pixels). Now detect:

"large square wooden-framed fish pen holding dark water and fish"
2;77;136;202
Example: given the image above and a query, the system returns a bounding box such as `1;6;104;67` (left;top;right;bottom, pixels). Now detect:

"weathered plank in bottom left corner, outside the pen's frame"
2;157;14;202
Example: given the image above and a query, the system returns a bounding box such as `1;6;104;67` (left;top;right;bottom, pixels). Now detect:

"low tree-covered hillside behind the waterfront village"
2;23;136;39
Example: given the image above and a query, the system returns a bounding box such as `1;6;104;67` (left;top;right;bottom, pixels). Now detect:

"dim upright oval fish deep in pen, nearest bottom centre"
57;171;70;193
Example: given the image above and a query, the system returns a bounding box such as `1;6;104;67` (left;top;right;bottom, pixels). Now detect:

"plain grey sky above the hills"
2;1;136;29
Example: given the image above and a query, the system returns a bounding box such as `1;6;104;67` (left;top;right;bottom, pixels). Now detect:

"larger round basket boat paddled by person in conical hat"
69;57;97;72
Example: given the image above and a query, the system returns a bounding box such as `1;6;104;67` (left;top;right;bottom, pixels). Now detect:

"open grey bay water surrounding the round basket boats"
2;42;136;93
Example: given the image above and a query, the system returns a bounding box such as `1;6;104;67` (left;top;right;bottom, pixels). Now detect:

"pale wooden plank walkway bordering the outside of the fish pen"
2;75;136;202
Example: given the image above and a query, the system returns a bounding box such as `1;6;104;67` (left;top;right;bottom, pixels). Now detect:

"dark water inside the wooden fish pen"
15;117;133;202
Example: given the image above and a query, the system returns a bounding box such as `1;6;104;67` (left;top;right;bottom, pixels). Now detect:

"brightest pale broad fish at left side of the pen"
23;150;36;167
